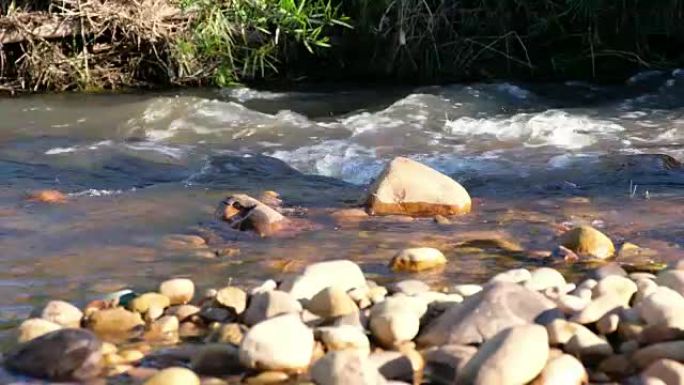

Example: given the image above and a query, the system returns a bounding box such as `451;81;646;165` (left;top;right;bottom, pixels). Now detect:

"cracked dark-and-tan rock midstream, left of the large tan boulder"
217;194;287;237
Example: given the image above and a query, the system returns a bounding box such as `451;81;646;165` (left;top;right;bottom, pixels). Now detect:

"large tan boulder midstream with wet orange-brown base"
366;157;471;216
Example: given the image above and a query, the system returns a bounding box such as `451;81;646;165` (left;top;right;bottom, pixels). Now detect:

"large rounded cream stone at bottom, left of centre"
239;314;314;372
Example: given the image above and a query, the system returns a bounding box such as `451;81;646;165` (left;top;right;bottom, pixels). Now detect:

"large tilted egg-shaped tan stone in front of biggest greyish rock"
456;325;549;385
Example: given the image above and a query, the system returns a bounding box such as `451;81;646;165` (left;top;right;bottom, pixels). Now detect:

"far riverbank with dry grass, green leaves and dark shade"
0;0;684;91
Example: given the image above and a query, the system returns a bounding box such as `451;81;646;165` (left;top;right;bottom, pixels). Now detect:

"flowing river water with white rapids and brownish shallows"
0;71;684;368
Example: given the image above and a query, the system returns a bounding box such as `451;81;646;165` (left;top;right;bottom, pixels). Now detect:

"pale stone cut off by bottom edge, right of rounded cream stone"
310;350;387;385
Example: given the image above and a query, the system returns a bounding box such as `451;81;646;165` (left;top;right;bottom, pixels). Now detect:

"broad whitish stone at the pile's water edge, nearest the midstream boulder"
279;260;367;299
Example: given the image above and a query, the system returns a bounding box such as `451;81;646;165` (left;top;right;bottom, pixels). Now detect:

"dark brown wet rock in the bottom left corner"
4;329;102;381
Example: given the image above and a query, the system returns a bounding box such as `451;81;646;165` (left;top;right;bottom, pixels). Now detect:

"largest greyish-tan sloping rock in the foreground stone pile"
417;283;561;346
